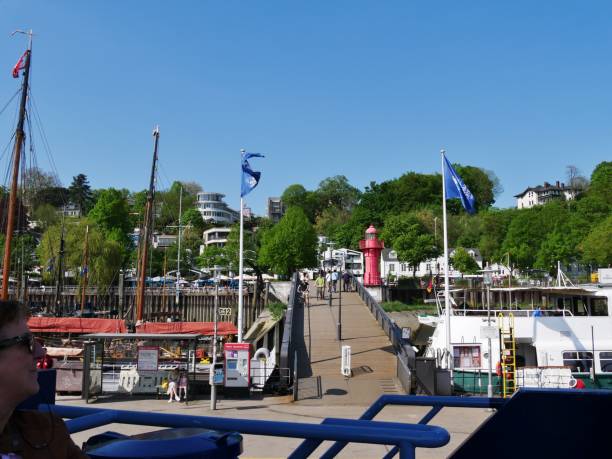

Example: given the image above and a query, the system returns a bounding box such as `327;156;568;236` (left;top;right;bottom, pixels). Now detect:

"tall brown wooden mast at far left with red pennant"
0;37;32;301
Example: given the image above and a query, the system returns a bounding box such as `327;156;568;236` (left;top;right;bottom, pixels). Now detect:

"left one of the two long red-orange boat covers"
28;317;127;334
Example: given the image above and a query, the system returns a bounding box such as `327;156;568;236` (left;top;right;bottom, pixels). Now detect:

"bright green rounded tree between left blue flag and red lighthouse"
259;207;317;276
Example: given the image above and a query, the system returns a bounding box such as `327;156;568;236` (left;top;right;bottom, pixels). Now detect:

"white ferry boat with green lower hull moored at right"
424;278;612;395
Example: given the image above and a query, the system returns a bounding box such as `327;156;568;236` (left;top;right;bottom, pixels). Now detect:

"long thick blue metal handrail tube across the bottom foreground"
39;405;450;459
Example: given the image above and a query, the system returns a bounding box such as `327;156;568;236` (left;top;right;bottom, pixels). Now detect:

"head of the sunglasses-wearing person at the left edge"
0;301;45;406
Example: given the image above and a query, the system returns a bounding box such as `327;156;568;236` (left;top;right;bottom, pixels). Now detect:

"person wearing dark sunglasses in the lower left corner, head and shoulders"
0;301;87;459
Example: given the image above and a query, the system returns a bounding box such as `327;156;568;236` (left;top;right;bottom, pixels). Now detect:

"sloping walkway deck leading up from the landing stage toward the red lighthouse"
298;285;404;406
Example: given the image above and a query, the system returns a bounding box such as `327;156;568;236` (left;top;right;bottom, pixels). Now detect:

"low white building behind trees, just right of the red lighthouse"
380;248;482;279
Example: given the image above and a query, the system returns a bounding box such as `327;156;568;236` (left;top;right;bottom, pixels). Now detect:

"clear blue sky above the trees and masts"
0;0;612;213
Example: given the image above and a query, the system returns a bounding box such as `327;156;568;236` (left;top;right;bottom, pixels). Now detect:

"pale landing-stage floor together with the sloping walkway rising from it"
58;292;490;458
